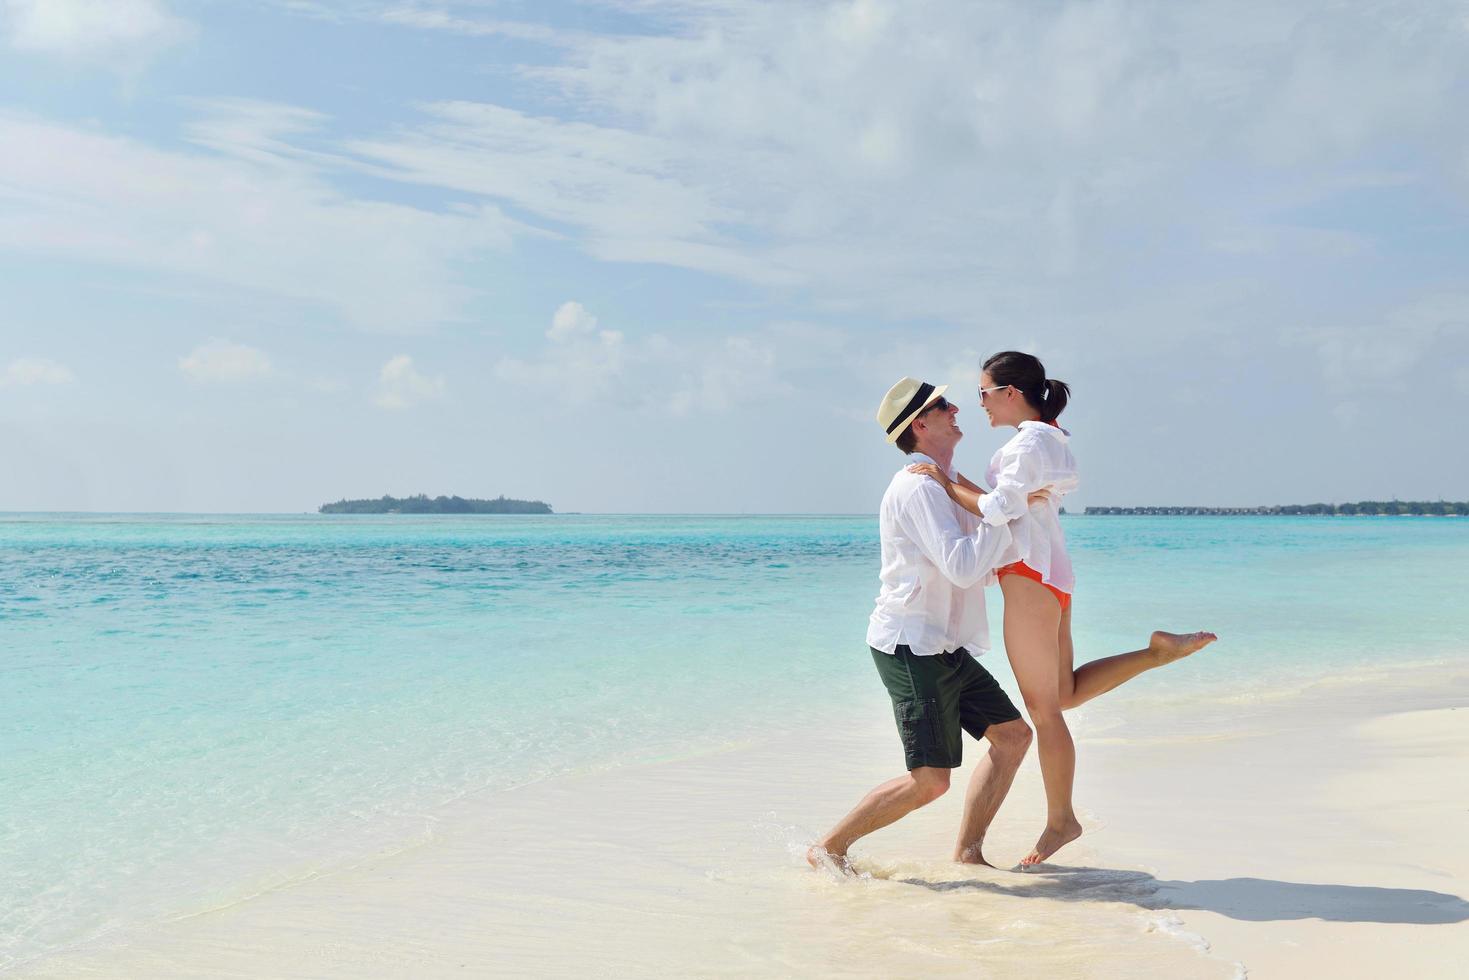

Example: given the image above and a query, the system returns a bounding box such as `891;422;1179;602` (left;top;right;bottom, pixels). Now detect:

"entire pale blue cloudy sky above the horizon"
0;0;1469;513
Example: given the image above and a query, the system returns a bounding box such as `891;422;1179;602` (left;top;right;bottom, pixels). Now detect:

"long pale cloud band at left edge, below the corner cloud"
0;101;517;334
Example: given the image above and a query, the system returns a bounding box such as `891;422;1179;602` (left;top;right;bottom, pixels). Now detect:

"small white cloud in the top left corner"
3;0;194;65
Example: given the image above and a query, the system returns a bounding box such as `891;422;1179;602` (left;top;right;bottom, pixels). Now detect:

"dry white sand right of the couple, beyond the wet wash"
1081;671;1469;979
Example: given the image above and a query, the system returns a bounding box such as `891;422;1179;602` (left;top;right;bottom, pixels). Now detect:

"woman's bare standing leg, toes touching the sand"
1000;574;1081;867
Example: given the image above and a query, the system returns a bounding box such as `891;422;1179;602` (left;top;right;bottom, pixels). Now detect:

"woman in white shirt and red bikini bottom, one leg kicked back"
909;351;1216;867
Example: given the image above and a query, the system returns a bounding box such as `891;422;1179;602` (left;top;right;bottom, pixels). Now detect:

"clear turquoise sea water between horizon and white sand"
0;514;1469;970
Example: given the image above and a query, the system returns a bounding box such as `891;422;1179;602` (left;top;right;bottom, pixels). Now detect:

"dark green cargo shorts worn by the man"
870;645;1019;770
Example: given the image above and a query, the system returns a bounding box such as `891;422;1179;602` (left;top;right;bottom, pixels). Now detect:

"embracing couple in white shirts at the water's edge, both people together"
806;351;1215;873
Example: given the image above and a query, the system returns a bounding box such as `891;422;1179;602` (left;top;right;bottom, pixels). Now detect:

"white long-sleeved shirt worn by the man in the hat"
867;453;1011;657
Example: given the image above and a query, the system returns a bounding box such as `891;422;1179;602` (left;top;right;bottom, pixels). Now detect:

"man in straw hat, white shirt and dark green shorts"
806;378;1031;873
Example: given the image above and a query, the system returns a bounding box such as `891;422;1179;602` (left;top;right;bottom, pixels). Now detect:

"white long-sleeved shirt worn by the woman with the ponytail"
980;422;1080;594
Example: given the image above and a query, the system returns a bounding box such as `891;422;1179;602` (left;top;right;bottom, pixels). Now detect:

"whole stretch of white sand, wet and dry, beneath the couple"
22;670;1469;979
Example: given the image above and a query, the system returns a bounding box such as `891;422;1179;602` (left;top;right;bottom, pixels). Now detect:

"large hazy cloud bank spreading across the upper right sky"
333;0;1469;326
